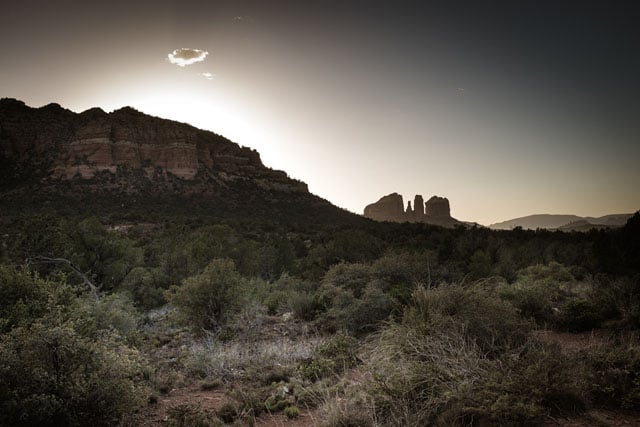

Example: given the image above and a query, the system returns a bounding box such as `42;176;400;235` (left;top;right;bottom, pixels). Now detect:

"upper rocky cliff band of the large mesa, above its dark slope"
0;99;308;192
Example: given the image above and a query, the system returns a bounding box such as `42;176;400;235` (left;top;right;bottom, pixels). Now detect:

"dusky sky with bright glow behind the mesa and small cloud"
0;0;640;225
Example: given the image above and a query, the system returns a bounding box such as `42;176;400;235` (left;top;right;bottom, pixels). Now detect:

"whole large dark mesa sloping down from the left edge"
0;98;363;223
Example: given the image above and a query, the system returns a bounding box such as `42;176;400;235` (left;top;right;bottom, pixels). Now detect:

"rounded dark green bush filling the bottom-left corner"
0;319;145;426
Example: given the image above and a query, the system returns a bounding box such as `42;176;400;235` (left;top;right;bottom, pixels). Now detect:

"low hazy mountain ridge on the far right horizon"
489;214;633;231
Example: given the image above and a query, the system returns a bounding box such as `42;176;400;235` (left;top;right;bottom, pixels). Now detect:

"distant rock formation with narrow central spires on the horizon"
364;193;462;227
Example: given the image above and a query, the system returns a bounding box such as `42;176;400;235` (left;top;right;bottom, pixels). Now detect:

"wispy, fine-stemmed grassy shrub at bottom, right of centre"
364;318;493;426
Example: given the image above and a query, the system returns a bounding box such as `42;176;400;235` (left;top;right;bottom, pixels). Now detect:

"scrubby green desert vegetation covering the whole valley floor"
0;213;640;426
